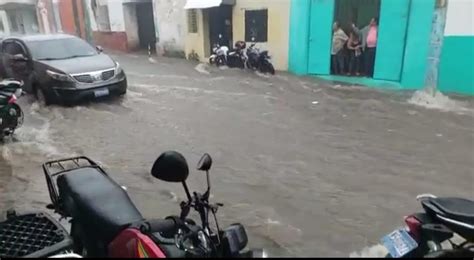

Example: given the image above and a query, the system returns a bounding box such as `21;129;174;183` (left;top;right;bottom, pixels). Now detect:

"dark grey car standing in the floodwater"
0;34;127;105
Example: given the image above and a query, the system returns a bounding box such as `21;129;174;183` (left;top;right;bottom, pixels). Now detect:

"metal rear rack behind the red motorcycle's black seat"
43;156;108;215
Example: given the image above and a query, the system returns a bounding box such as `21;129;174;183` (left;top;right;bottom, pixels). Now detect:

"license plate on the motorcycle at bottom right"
381;229;418;258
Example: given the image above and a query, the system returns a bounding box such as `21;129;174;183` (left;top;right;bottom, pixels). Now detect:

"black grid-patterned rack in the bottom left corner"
0;211;73;258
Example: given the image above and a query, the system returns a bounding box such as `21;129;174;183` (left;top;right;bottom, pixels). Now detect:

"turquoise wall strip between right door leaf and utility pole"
401;0;435;89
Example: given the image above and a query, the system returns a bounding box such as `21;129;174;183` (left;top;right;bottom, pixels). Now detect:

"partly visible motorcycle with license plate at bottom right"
382;194;474;258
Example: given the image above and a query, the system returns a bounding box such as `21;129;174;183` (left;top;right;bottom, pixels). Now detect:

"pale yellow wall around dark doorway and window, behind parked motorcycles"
185;0;291;70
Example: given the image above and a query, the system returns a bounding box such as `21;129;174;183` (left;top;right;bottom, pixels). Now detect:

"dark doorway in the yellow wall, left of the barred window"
207;4;233;53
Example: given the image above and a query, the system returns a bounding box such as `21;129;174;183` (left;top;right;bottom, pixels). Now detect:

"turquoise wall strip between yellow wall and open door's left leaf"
288;0;311;75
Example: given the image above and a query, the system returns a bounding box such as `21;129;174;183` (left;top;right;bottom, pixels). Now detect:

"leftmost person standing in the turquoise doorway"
331;21;349;74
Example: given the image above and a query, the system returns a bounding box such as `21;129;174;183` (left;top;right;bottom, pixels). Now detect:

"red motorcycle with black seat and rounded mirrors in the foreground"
38;152;265;258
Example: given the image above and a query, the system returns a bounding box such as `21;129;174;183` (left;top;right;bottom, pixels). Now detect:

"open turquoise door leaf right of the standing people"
374;0;410;81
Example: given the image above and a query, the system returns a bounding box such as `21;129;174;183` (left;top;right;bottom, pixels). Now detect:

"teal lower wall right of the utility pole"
438;36;474;95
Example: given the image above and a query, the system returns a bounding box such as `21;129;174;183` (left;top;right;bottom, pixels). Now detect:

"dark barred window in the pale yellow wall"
245;9;268;42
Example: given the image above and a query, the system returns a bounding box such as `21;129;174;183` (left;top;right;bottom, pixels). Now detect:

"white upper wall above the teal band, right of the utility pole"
444;0;474;36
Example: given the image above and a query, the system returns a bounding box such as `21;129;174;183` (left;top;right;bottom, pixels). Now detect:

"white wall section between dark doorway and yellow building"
153;0;186;52
